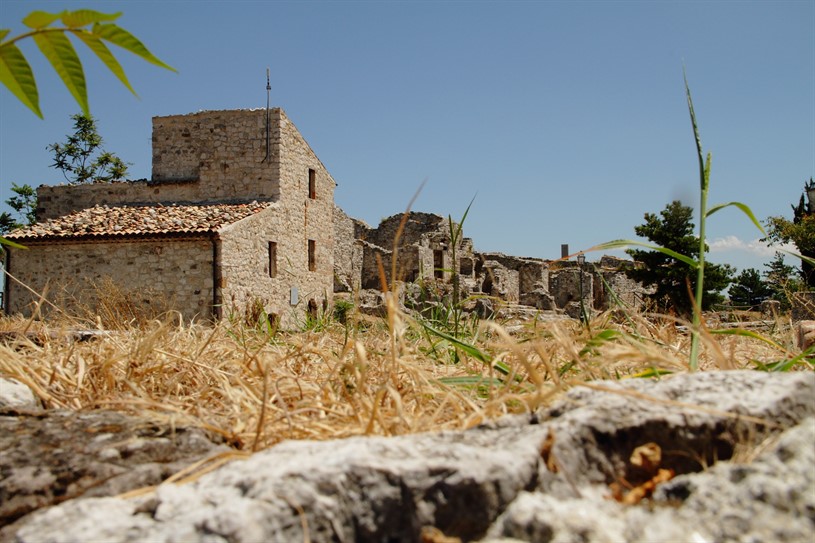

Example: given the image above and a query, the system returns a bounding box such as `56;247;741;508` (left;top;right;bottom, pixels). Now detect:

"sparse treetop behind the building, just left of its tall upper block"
48;113;127;185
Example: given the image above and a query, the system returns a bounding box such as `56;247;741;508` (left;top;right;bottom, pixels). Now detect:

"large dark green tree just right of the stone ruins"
626;200;734;317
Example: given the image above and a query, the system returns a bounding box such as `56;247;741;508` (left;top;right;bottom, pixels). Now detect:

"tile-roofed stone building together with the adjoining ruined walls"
4;109;641;328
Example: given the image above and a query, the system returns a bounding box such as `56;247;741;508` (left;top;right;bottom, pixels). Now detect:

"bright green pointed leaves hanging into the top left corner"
0;9;175;118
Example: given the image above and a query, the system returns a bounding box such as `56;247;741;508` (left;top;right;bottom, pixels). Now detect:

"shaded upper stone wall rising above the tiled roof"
37;109;286;221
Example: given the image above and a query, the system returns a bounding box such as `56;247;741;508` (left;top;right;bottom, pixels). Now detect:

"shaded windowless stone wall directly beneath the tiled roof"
7;238;213;319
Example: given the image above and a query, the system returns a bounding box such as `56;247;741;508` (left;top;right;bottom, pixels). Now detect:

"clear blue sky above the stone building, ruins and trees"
0;0;815;268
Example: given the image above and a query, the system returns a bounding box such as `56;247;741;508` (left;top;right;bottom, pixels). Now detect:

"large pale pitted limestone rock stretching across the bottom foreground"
7;371;815;543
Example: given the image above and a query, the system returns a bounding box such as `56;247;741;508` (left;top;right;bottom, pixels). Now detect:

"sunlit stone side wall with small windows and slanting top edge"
214;109;335;328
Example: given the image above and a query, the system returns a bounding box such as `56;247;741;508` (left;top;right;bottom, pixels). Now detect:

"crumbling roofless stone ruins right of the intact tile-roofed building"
334;208;646;318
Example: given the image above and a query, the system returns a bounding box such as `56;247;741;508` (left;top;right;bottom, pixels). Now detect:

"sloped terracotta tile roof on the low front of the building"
6;202;271;240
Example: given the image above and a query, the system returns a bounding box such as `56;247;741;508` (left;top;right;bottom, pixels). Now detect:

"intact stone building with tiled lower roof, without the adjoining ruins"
5;109;335;327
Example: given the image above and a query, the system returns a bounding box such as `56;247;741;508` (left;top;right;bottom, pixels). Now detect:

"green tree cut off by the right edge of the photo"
765;177;815;290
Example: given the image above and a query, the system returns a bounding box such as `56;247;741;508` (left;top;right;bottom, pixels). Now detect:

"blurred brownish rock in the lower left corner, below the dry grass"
0;409;227;537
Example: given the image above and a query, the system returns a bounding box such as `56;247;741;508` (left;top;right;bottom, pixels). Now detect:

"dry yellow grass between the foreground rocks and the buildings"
0;300;804;451
